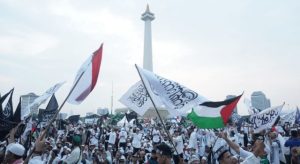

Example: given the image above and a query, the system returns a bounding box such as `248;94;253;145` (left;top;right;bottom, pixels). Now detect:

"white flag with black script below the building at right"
250;104;284;133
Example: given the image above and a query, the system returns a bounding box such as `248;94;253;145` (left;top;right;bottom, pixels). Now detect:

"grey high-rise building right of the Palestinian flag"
251;91;271;111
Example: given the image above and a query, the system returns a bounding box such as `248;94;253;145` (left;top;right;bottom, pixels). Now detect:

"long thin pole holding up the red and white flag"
24;72;85;163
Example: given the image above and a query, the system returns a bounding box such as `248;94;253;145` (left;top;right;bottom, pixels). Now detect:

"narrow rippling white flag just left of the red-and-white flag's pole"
21;82;65;120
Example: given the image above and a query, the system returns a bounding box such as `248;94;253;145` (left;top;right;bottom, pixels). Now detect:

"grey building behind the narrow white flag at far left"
21;92;39;116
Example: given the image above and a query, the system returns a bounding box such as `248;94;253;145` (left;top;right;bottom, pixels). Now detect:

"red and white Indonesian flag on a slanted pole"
68;44;103;104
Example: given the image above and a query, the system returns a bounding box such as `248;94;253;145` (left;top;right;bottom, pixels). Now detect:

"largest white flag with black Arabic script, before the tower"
136;65;207;114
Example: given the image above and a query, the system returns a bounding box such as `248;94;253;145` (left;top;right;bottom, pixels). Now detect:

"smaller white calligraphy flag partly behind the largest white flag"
119;81;161;116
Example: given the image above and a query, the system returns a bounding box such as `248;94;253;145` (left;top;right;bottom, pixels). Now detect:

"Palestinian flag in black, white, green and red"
187;94;243;129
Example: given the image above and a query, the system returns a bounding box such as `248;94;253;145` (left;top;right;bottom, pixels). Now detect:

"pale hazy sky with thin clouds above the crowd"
0;0;300;115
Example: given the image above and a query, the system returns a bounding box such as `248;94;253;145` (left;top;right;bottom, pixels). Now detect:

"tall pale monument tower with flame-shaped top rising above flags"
141;5;155;71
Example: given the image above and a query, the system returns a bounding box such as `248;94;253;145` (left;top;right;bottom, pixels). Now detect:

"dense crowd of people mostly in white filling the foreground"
0;117;300;164
